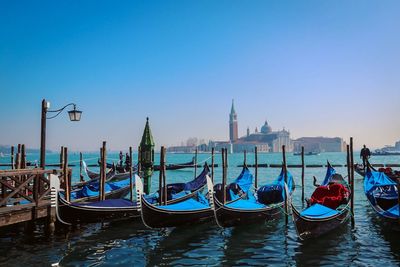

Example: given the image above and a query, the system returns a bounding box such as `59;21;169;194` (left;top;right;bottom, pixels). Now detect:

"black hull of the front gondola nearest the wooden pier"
58;197;140;224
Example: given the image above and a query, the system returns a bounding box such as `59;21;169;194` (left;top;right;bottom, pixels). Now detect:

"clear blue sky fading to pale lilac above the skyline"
0;0;400;150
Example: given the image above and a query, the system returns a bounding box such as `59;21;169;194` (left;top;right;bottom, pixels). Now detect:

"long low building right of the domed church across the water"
293;137;346;153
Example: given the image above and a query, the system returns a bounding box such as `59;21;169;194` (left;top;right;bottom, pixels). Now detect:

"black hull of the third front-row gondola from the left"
215;198;284;227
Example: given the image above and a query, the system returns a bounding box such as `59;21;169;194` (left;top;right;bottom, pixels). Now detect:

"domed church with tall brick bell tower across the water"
209;100;293;153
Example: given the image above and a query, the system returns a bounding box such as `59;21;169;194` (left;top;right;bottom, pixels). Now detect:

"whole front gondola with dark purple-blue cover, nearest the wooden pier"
50;175;140;224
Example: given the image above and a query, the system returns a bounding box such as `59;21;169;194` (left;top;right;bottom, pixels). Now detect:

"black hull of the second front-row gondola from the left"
141;196;214;228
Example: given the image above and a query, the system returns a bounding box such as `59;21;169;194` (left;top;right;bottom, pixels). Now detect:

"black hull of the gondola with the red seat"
292;205;350;240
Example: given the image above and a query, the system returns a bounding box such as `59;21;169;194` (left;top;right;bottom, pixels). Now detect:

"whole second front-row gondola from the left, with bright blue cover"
136;174;214;228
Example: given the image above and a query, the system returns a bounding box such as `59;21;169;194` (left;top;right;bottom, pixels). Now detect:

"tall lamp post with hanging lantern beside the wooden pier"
40;99;82;169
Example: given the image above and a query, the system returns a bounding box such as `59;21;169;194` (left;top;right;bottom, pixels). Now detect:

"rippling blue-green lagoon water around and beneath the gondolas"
0;153;400;266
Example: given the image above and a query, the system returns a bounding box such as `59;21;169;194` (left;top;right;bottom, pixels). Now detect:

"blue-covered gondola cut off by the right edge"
364;168;399;222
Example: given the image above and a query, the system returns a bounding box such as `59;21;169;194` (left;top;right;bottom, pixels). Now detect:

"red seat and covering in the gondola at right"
310;183;349;209
